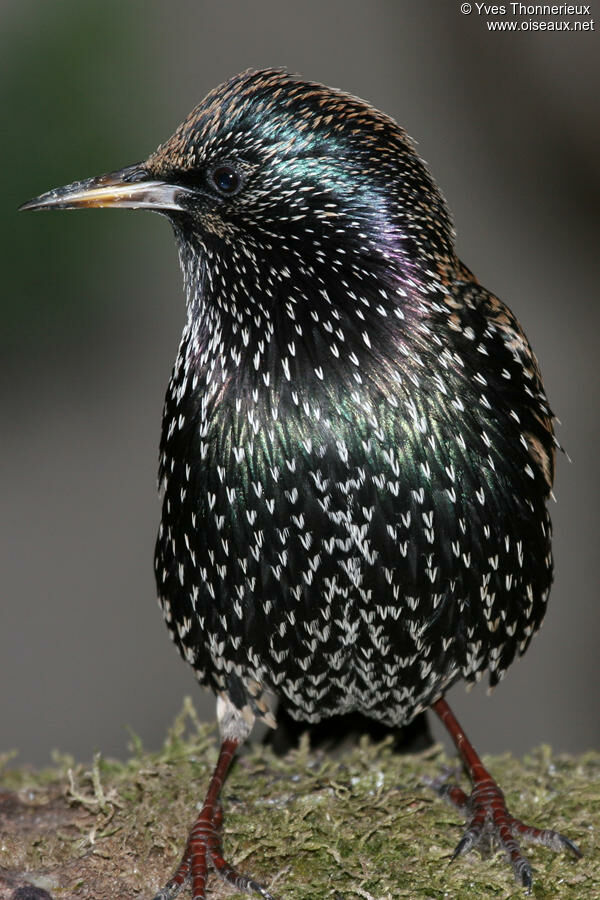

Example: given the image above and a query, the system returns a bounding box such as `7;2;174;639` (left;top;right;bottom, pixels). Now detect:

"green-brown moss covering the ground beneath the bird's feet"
0;700;600;900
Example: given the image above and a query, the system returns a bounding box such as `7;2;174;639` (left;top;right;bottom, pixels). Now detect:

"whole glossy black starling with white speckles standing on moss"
22;68;581;900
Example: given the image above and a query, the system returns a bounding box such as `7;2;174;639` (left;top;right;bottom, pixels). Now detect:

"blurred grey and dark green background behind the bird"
0;0;600;764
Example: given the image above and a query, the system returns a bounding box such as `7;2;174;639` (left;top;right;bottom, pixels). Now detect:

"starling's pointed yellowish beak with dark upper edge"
19;163;192;212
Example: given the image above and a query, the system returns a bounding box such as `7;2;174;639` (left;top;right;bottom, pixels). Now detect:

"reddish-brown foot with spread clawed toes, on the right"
434;772;583;893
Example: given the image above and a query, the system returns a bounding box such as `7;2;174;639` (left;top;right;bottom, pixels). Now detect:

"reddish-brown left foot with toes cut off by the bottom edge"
154;804;275;900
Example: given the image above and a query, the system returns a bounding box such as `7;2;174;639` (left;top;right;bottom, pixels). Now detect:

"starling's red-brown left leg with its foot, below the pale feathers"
154;739;274;900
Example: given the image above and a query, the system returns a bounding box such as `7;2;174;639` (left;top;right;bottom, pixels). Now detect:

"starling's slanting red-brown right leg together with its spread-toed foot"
432;700;582;892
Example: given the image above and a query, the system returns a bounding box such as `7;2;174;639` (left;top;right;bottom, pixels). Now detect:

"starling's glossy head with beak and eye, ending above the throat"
22;69;453;278
